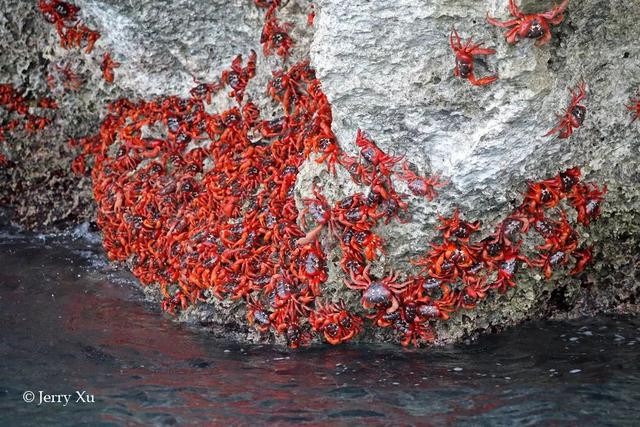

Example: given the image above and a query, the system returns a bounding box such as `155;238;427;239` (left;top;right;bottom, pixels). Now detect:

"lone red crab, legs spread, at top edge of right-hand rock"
487;0;569;46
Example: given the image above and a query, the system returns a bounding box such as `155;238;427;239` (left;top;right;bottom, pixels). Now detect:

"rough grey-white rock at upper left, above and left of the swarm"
0;0;311;229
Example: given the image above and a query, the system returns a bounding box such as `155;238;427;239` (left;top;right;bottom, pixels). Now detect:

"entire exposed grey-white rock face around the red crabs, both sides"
0;0;640;342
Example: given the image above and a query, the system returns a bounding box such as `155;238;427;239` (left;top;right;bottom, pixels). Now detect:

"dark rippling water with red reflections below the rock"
0;229;640;426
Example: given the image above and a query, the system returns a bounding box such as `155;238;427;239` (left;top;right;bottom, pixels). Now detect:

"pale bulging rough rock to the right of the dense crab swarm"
306;0;640;341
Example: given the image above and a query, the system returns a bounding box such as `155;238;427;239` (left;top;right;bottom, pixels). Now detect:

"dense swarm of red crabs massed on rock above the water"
58;1;606;347
